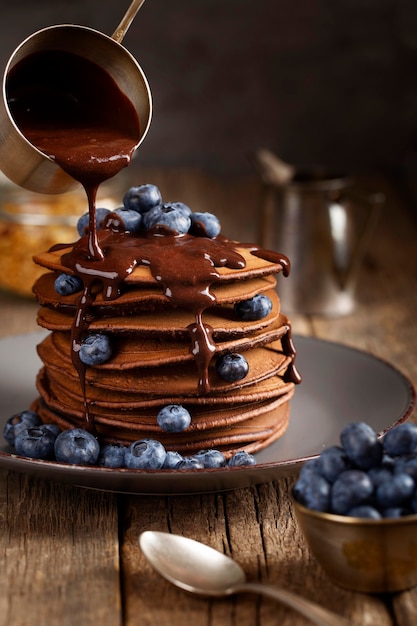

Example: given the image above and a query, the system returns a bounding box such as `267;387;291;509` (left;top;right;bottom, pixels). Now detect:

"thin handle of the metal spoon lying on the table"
233;583;352;626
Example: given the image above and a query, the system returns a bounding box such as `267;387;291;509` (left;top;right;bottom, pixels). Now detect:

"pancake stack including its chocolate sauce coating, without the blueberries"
33;222;300;458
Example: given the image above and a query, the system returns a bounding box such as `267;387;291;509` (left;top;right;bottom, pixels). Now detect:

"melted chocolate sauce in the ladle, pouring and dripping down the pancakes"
7;51;299;429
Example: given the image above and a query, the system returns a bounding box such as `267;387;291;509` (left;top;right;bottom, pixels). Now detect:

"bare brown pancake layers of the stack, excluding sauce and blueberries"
33;235;299;457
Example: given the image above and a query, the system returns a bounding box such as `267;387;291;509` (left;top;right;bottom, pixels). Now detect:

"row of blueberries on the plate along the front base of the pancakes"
3;410;256;470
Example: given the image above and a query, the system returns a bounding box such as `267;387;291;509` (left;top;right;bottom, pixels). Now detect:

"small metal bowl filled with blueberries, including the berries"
293;422;417;593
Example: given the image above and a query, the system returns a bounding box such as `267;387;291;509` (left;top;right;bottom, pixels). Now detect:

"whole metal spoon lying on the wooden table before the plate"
139;530;350;626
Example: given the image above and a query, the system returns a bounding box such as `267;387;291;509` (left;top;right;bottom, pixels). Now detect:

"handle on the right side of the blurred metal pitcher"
328;190;385;289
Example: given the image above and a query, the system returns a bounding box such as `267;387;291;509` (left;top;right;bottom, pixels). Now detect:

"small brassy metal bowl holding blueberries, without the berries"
293;499;417;593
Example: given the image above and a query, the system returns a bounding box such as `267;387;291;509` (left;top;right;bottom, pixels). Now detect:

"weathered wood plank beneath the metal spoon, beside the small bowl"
121;480;392;626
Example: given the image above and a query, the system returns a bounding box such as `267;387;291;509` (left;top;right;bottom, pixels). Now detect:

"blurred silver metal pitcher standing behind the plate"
260;171;385;316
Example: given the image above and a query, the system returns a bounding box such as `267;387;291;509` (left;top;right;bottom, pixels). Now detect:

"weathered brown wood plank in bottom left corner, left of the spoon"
0;471;122;626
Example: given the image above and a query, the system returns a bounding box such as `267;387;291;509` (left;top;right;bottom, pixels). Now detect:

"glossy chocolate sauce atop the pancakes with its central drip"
61;229;246;393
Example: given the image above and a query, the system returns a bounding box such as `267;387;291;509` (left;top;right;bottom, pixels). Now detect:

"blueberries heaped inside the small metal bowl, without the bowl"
293;422;417;519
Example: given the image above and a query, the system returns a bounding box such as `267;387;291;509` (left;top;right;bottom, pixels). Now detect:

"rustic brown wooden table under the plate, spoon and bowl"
0;169;417;626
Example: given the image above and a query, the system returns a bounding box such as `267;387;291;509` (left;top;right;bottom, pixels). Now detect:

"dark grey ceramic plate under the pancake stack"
0;332;415;495
